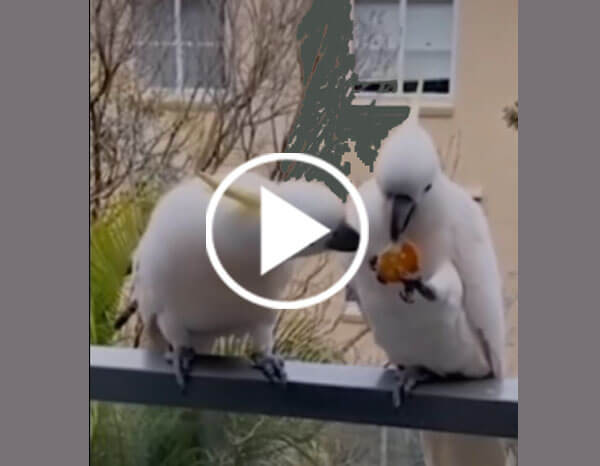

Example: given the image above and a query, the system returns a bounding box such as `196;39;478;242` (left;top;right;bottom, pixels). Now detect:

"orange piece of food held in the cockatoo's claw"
375;241;420;283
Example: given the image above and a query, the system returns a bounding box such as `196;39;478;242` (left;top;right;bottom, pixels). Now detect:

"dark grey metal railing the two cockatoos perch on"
90;346;518;438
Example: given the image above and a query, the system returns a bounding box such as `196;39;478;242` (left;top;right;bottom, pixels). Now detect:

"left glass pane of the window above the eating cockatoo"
354;0;401;81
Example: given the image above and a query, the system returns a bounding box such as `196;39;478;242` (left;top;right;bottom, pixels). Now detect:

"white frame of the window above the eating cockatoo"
350;0;460;116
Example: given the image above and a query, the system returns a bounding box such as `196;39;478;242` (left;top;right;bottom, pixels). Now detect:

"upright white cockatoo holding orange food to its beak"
348;111;504;466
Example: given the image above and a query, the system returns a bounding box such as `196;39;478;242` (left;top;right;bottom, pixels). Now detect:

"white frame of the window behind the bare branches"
133;0;232;104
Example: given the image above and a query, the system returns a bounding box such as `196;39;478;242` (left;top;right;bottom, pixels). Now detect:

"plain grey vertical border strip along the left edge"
0;1;89;466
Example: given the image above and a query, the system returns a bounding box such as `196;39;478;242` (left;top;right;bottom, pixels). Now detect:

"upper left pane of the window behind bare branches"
132;0;175;43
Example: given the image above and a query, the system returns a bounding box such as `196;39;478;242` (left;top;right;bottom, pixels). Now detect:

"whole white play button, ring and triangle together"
206;154;369;311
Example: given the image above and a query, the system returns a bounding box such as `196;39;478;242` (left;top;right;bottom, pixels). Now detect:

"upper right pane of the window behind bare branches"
181;0;223;43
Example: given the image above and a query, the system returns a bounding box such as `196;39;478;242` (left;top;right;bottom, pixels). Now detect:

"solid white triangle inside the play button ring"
260;186;330;275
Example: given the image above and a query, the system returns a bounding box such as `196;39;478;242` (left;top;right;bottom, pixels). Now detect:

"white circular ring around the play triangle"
206;153;369;310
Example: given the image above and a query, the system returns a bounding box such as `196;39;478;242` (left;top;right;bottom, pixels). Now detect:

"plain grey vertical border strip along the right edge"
519;0;600;466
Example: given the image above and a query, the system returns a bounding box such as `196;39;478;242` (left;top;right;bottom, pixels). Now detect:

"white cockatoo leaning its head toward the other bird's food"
132;173;359;389
